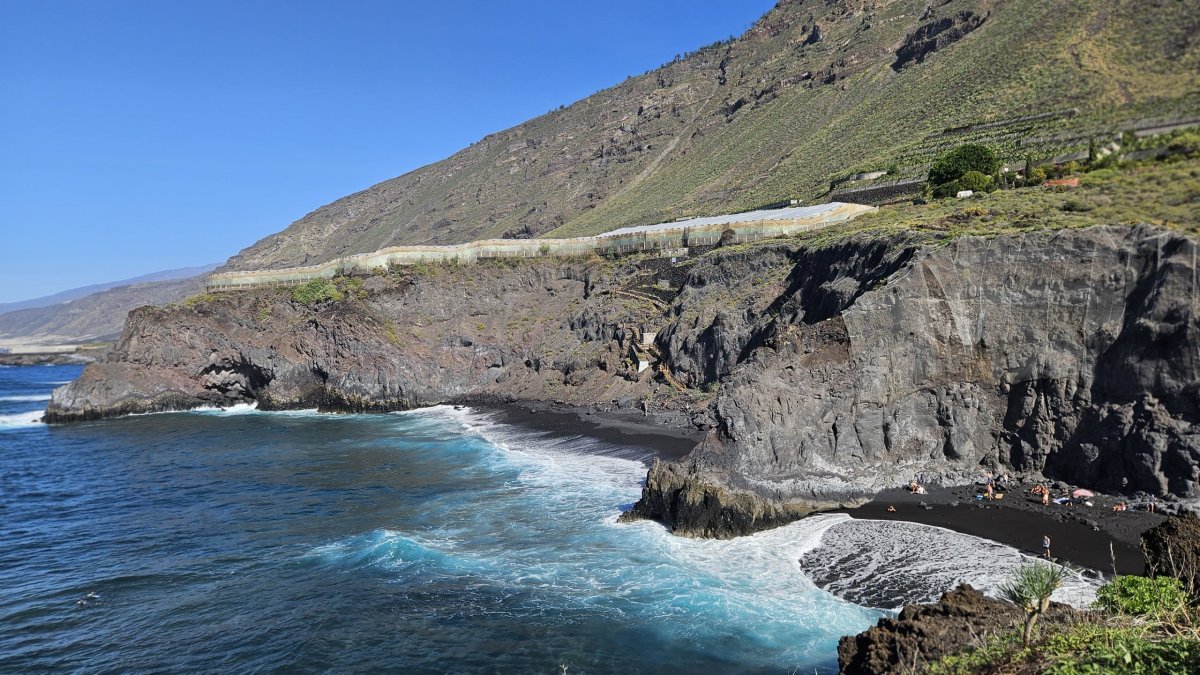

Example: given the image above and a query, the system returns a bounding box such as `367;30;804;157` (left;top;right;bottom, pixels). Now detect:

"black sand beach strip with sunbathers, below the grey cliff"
840;484;1165;574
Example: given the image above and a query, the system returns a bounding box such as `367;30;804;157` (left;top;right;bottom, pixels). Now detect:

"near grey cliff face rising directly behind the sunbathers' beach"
635;227;1200;532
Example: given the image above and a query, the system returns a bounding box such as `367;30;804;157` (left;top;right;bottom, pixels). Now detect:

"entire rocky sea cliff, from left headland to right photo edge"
48;227;1200;537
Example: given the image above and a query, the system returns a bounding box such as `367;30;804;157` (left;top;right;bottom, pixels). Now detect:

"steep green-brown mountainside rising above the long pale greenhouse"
224;0;1200;270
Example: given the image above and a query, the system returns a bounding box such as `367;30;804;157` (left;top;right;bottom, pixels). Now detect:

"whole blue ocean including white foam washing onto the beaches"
0;366;1094;673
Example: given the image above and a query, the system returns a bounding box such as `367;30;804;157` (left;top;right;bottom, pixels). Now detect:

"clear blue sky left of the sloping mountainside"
0;0;774;301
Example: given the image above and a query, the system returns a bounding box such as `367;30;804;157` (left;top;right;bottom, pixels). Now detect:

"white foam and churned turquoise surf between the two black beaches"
355;406;880;661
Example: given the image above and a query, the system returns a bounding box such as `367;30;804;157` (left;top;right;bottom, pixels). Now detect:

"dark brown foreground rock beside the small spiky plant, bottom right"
838;584;1079;675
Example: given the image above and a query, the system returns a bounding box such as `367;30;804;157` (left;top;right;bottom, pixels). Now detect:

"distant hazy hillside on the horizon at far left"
0;276;204;345
